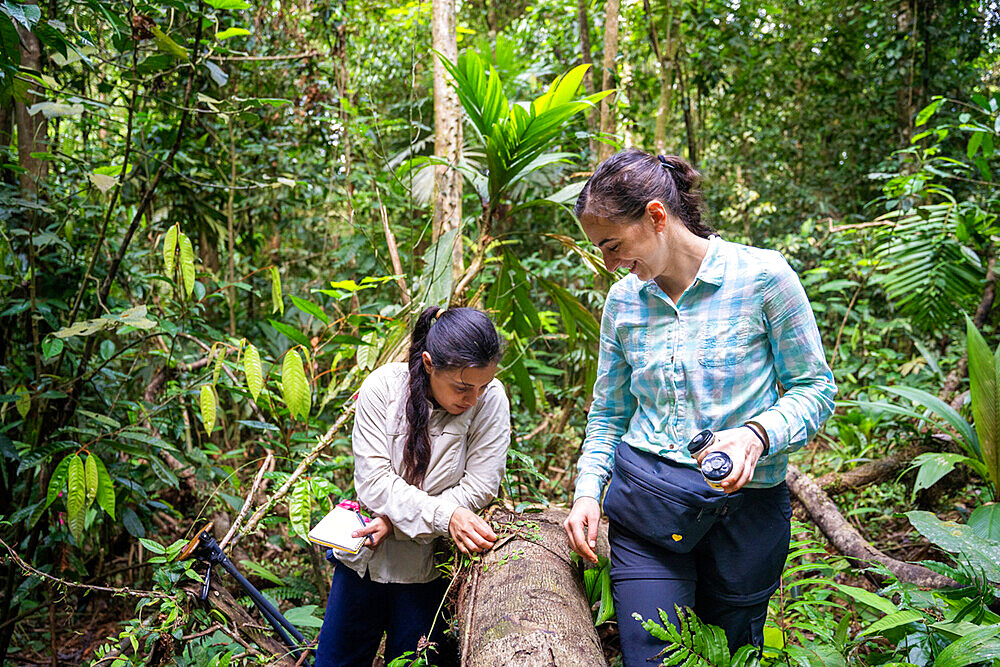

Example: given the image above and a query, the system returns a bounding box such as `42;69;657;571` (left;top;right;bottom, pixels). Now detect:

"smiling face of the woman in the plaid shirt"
580;202;667;281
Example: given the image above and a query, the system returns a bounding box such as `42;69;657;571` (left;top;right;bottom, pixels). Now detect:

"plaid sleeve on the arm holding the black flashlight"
755;256;837;456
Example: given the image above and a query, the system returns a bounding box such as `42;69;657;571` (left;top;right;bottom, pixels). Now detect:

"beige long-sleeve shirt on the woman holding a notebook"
335;363;510;583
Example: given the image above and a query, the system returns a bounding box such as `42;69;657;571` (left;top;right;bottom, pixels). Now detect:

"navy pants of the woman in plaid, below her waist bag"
609;482;792;667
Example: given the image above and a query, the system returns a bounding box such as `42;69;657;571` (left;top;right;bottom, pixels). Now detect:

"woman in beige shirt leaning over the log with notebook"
316;306;510;667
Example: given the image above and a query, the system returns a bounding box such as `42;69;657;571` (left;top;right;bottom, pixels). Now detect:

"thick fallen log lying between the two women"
455;508;608;667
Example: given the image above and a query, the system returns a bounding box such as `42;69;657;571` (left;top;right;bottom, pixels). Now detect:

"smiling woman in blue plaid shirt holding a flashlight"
565;149;837;667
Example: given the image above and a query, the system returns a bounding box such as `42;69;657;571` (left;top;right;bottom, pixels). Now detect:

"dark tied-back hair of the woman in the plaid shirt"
573;148;715;238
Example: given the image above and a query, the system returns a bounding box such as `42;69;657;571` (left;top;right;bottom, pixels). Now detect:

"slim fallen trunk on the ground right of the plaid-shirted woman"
785;465;958;588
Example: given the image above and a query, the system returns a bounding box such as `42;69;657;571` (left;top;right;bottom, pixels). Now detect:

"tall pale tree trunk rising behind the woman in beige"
431;0;463;280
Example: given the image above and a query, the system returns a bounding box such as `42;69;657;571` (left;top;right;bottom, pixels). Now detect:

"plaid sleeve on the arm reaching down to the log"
573;288;637;502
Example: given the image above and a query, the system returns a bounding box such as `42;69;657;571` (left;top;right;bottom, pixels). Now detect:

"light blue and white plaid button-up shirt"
574;236;837;499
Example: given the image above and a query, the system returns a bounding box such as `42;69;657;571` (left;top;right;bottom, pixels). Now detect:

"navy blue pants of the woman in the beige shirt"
315;565;448;667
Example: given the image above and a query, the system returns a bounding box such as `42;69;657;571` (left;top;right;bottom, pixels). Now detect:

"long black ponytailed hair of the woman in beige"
403;306;500;486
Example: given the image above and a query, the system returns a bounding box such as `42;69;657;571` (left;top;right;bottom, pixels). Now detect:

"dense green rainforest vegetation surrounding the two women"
0;0;1000;665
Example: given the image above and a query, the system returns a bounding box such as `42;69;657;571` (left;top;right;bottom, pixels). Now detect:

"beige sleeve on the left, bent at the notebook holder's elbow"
352;371;455;539
